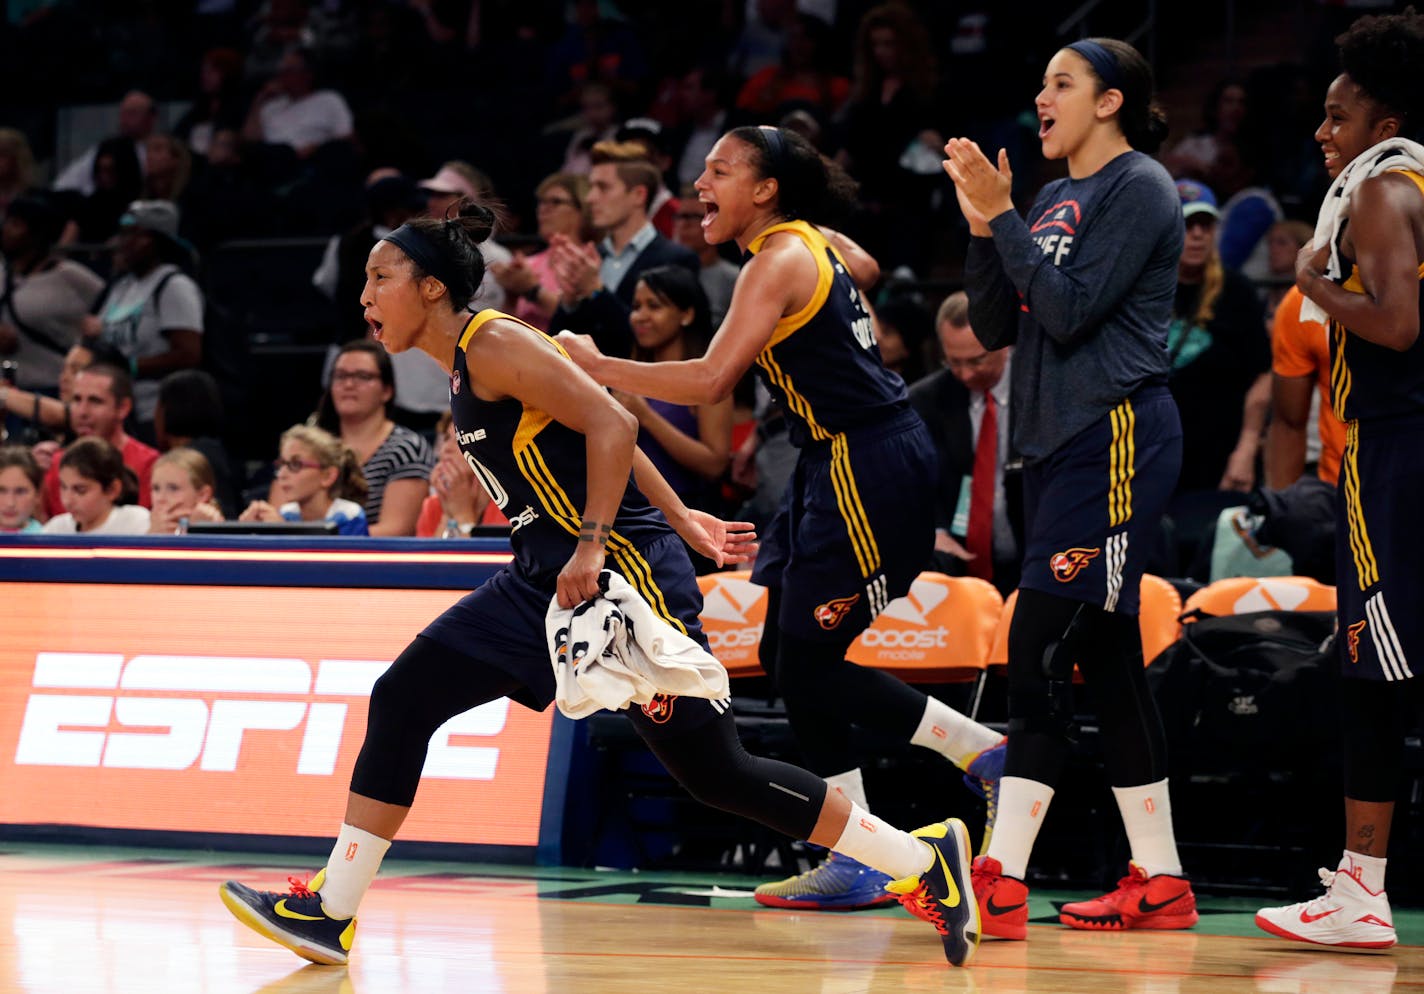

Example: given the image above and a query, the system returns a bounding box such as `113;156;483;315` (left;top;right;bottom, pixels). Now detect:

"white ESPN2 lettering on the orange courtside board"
14;652;510;780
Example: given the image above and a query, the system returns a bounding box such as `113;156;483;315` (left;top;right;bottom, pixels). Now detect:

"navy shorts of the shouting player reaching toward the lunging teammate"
752;410;936;642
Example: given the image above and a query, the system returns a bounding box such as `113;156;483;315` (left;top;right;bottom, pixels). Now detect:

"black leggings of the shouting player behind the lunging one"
759;587;926;776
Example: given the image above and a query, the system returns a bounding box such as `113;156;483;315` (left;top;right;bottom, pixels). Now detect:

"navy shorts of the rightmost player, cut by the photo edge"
1336;416;1424;681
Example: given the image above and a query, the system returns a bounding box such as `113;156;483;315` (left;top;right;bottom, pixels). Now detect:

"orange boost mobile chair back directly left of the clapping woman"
846;572;1004;684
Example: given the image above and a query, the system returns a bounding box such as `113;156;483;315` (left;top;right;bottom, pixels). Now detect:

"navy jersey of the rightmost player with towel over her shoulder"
1330;169;1424;422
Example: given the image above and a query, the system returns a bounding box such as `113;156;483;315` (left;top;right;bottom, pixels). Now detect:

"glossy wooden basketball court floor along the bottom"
0;844;1424;994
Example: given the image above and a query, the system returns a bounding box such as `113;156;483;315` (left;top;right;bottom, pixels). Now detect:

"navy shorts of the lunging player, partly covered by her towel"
420;533;731;738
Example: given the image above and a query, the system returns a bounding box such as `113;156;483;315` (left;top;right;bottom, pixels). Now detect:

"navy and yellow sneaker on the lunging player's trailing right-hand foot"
886;817;980;967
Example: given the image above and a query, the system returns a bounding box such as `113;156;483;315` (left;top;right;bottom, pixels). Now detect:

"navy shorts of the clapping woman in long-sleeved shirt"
1020;386;1182;615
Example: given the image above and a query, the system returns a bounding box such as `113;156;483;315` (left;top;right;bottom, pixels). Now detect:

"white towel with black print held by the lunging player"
544;570;728;718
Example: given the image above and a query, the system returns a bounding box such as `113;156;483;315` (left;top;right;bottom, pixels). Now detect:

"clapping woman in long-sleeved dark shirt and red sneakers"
944;38;1196;938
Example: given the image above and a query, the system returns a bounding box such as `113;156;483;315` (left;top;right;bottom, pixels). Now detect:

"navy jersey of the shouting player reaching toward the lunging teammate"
748;221;910;447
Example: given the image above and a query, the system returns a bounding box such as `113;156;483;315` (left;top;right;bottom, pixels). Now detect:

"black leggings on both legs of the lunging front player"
352;637;826;839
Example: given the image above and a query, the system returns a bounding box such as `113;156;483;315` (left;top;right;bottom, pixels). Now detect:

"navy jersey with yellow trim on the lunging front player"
450;310;672;589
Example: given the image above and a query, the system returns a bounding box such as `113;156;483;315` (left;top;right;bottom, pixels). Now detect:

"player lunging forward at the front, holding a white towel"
222;202;978;964
